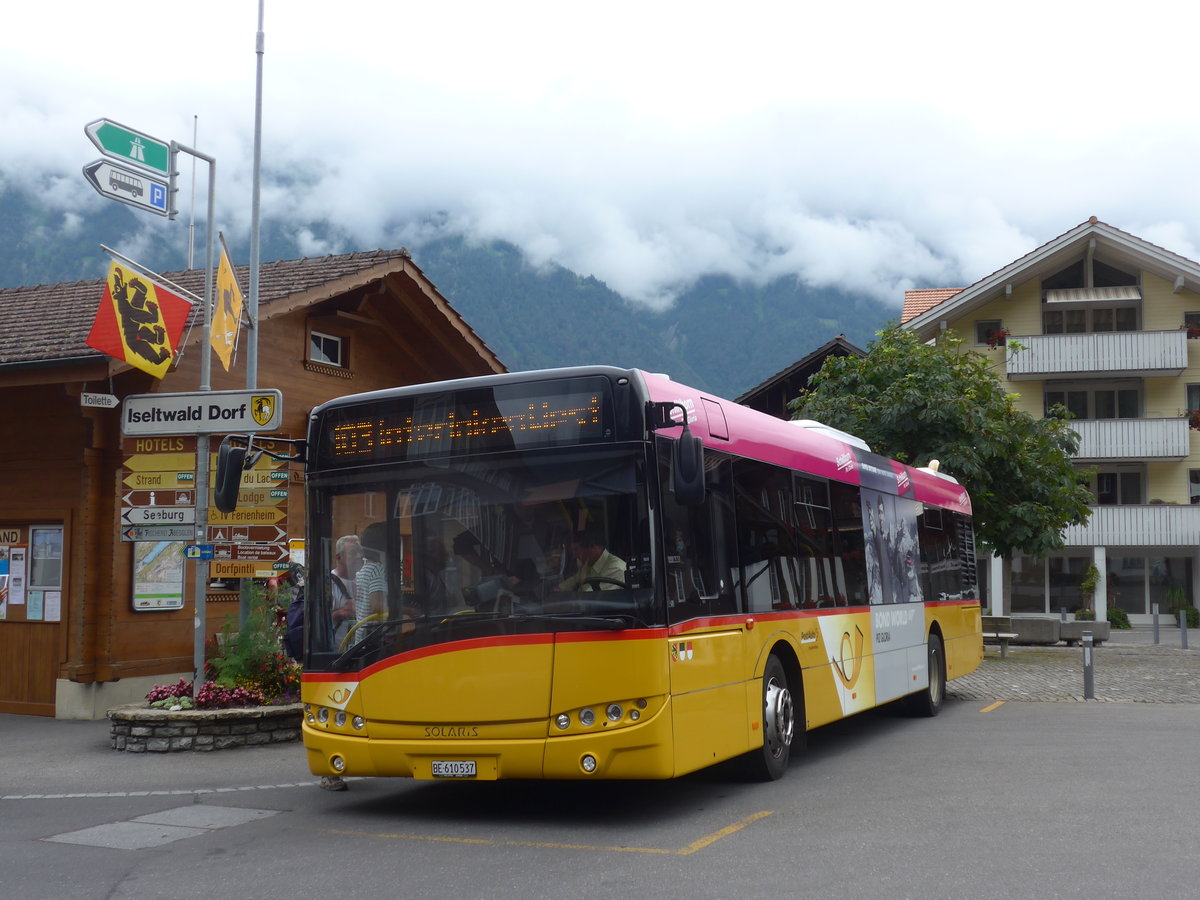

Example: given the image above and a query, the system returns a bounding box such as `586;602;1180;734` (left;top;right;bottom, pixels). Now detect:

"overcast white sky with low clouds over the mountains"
0;0;1200;305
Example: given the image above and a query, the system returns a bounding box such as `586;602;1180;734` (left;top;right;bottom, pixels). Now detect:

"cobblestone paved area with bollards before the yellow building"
947;626;1200;703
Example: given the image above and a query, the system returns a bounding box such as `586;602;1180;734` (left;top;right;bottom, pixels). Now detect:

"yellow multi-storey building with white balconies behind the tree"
901;217;1200;624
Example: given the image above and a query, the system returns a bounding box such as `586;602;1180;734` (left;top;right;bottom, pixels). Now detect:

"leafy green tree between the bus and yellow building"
791;323;1091;607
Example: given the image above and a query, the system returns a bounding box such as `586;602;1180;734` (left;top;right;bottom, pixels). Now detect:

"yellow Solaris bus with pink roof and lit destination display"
226;366;983;780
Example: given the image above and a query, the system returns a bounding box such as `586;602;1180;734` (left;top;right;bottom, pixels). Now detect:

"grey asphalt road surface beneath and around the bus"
0;648;1200;900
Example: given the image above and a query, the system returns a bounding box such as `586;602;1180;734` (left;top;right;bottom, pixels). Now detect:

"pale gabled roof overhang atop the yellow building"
907;217;1200;340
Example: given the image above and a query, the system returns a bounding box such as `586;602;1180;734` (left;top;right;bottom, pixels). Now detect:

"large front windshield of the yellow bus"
305;444;665;672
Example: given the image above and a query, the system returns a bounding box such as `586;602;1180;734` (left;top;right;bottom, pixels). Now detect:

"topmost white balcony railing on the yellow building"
1008;330;1188;382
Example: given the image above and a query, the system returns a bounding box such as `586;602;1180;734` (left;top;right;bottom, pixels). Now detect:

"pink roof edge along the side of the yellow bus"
641;372;971;515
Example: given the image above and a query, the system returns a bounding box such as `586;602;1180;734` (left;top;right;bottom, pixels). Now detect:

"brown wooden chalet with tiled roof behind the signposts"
0;250;505;719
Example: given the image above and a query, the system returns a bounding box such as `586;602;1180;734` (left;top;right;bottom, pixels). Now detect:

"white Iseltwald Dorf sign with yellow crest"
121;388;283;434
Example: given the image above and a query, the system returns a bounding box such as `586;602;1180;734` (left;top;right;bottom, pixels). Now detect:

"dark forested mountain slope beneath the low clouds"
0;184;898;397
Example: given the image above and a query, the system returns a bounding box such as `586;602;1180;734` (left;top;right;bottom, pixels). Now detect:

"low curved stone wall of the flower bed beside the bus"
108;703;304;754
